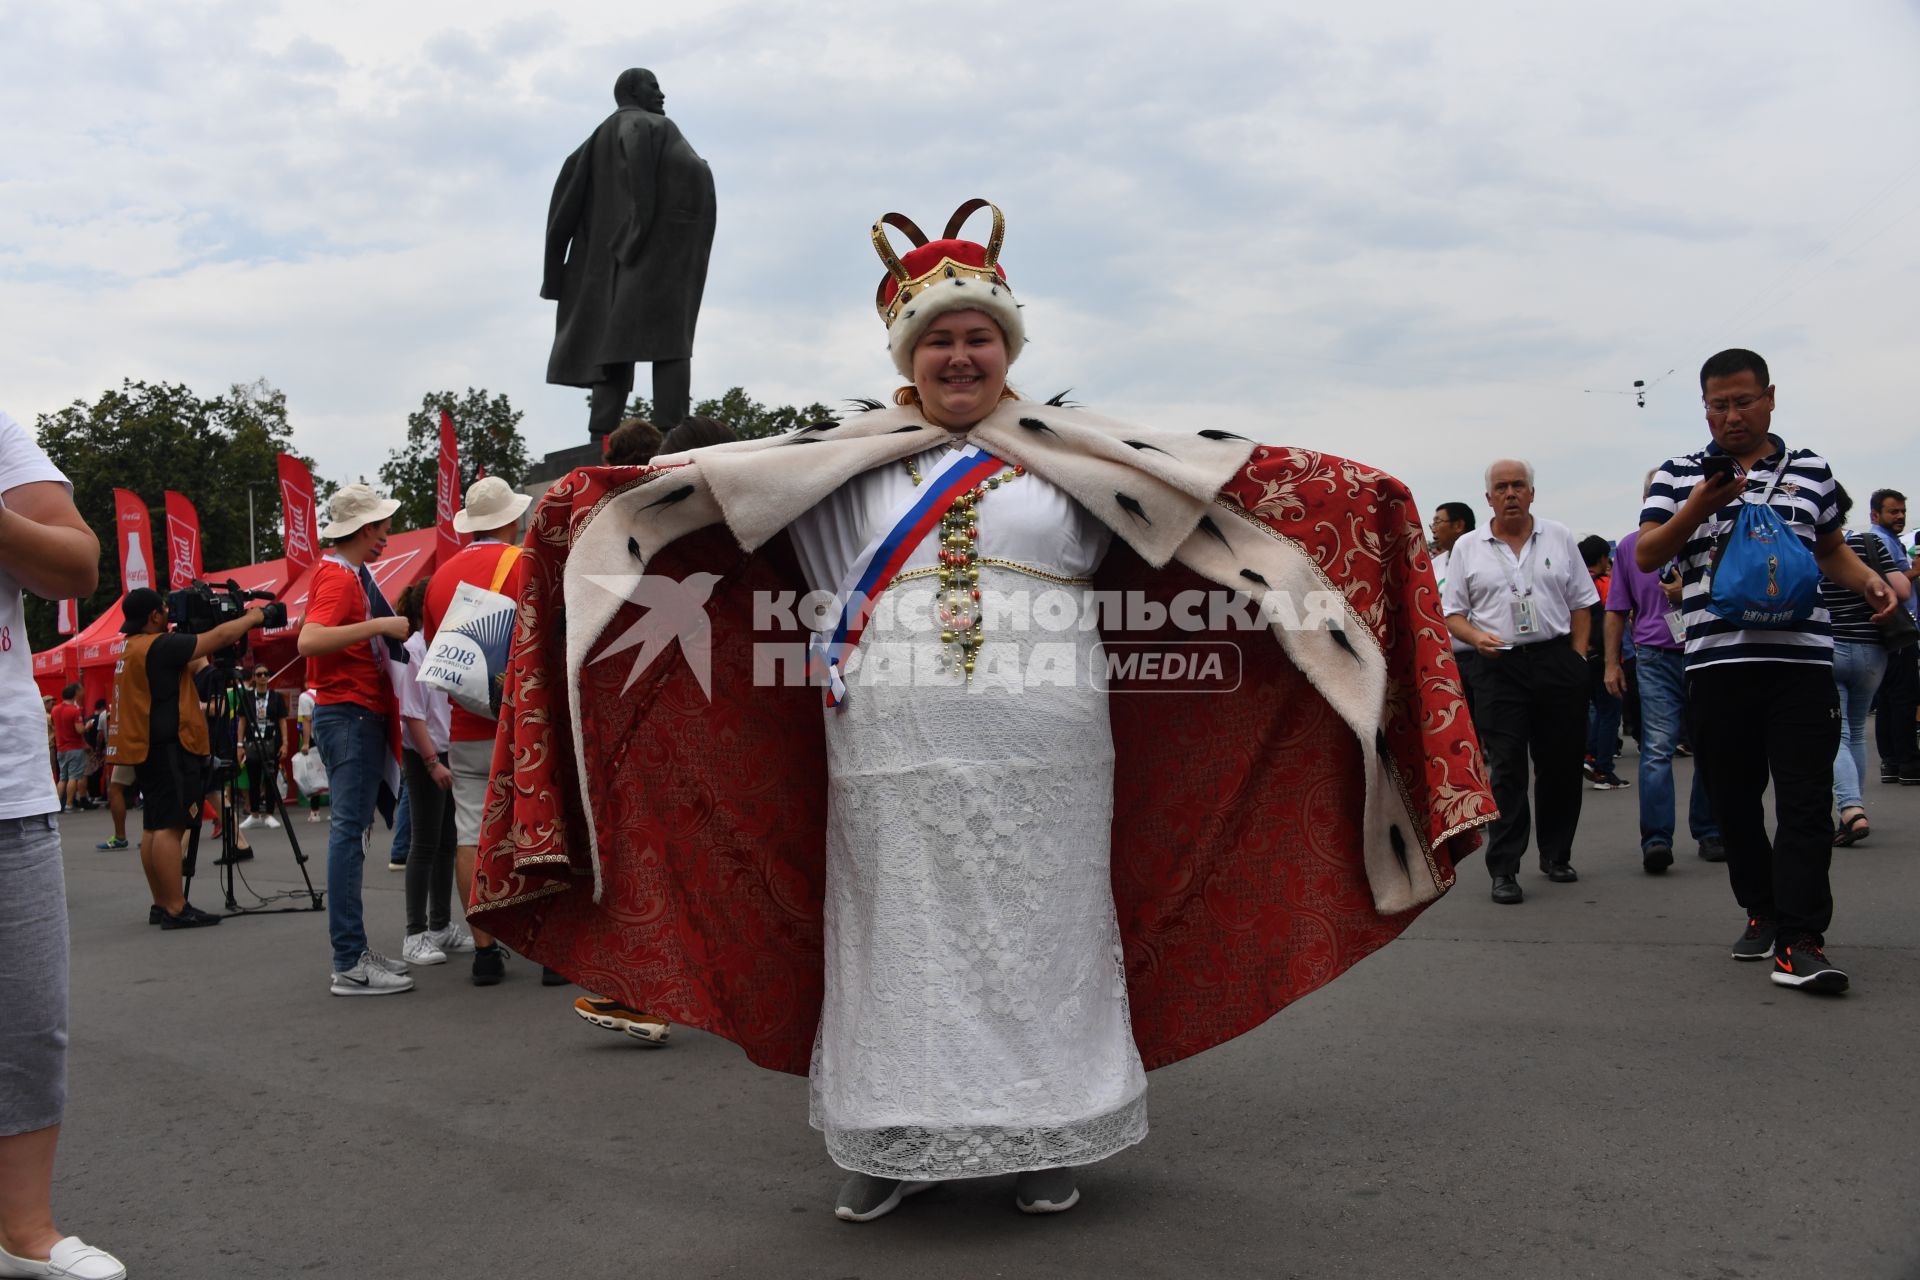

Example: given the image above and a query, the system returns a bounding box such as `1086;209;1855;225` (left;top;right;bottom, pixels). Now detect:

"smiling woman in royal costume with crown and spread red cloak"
472;201;1494;1221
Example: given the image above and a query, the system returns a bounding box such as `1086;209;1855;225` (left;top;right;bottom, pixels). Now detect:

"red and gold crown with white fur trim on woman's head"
874;200;1027;378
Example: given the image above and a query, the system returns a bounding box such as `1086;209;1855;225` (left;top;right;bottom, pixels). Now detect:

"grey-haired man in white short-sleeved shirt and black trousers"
1440;459;1599;904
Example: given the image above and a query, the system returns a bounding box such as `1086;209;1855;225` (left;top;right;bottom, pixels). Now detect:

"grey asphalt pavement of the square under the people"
37;758;1920;1280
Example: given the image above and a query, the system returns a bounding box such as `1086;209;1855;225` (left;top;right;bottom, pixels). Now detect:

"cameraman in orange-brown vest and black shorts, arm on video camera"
108;587;267;929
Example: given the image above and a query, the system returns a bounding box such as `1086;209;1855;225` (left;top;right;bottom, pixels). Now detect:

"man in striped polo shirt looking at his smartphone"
1634;347;1895;992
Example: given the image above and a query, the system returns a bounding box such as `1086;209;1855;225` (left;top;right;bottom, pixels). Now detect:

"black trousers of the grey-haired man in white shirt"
1463;637;1588;875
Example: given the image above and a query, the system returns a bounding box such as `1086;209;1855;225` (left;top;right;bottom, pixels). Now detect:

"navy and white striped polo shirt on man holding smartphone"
1640;436;1841;670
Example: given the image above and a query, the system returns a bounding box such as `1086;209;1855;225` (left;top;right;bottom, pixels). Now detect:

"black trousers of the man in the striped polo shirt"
1686;662;1839;938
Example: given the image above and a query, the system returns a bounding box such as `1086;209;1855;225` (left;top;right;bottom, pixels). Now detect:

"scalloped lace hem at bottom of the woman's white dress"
814;1094;1146;1180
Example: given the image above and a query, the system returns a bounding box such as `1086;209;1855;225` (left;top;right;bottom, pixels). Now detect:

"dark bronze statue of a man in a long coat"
540;67;714;438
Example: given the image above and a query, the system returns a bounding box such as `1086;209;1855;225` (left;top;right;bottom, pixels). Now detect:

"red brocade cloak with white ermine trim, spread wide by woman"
470;405;1494;1075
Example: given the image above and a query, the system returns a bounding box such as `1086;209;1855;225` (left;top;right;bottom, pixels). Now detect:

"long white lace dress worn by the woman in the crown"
789;449;1146;1178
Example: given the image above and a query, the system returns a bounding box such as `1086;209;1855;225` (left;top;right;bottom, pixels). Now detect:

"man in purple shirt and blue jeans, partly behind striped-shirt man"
1605;530;1726;875
